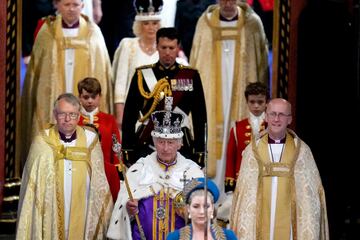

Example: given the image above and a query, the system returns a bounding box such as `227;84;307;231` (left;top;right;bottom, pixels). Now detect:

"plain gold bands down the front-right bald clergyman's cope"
252;134;300;239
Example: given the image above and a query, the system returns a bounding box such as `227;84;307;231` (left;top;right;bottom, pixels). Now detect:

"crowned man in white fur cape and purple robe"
107;106;203;239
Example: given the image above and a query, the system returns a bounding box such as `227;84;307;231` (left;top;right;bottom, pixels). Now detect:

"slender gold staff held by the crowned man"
112;134;146;240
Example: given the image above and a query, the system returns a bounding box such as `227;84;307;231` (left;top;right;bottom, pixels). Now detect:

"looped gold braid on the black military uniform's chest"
137;70;172;122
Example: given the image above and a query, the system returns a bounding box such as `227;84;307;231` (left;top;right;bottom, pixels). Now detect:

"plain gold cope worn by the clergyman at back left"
20;15;113;169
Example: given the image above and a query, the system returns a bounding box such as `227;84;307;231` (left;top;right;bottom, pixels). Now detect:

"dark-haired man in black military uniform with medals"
122;28;206;166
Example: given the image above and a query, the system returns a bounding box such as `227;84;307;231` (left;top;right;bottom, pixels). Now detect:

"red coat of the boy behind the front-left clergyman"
79;112;120;202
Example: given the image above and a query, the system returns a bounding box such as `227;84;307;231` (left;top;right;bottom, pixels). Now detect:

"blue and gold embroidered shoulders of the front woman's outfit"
166;224;237;240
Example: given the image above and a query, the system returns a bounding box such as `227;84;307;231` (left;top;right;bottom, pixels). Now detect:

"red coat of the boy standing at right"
225;118;265;192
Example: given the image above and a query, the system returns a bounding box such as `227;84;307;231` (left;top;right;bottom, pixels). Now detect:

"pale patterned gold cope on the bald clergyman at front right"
230;130;329;240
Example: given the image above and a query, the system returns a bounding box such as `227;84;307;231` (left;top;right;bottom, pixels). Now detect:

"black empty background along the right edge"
296;0;360;239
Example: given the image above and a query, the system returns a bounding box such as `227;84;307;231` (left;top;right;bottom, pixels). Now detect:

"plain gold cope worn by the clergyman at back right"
190;3;268;177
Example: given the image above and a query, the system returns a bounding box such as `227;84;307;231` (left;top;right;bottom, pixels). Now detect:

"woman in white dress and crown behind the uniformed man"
112;0;163;129
